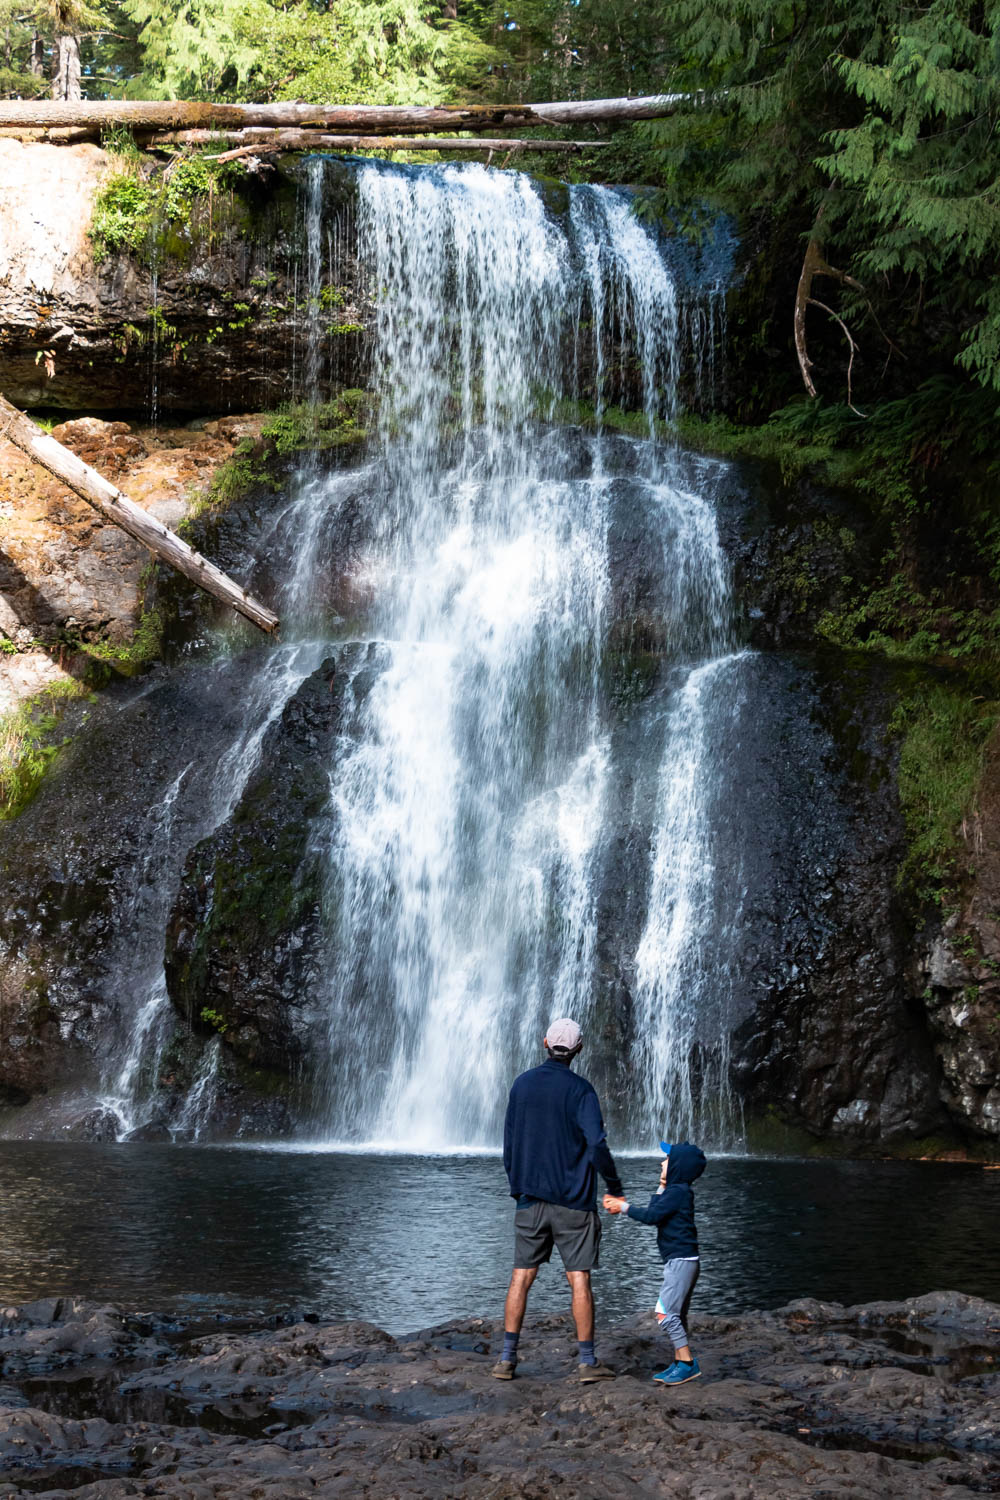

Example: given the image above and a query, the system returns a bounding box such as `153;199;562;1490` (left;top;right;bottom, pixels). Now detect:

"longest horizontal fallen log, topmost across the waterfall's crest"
0;95;685;135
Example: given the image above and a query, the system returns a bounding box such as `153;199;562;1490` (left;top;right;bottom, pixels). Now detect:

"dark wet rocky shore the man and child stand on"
0;1293;1000;1500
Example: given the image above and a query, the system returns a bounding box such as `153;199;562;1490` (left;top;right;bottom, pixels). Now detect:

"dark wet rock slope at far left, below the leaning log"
0;654;305;1140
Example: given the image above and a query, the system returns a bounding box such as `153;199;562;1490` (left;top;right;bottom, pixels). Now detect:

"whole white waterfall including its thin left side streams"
86;158;739;1149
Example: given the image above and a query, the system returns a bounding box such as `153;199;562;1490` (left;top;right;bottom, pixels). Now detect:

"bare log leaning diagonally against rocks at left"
0;396;279;635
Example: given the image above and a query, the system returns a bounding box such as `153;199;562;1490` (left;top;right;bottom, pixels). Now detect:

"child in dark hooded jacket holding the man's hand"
604;1140;705;1386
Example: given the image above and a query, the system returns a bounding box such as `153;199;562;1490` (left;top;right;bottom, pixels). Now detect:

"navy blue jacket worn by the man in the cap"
504;1058;622;1212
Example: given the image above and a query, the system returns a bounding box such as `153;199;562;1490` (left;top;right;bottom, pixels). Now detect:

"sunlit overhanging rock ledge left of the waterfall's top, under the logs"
0;141;367;414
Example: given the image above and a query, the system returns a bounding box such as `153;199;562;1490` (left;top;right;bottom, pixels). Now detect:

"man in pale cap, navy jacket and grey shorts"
490;1017;622;1385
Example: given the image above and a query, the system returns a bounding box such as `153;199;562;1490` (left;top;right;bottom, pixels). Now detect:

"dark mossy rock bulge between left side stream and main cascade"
166;642;385;1074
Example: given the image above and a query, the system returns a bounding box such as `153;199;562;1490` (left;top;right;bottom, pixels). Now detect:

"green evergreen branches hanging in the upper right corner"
629;0;1000;396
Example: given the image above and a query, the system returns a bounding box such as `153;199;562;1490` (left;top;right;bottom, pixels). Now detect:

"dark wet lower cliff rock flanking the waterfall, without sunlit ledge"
0;434;1000;1149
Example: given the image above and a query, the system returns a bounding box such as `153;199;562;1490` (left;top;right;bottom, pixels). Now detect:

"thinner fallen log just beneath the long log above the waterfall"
145;126;593;162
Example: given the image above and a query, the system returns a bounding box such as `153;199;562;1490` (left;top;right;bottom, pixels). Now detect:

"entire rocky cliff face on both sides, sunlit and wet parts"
0;141;1000;1151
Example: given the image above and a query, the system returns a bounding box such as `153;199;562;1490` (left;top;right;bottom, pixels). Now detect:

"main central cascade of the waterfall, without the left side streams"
295;164;730;1149
